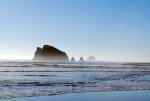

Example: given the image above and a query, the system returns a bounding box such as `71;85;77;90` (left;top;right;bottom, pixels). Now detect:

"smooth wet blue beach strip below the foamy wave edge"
0;90;150;101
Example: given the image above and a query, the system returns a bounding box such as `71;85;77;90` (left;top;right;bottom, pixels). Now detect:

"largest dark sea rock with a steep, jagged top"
33;45;69;61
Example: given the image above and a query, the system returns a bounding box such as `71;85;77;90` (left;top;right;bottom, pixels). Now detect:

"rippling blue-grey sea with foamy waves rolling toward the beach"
0;61;150;98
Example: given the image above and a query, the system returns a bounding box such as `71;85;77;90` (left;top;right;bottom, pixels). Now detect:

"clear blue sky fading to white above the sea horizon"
0;0;150;62
